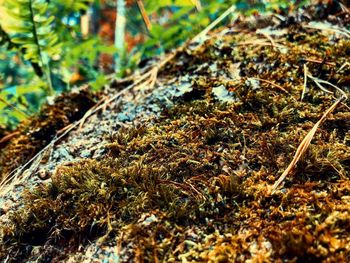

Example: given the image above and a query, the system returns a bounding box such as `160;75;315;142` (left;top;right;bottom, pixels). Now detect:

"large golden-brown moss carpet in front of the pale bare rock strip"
0;2;350;262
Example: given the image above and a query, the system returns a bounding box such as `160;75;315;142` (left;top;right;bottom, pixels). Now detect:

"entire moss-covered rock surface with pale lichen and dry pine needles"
0;2;350;262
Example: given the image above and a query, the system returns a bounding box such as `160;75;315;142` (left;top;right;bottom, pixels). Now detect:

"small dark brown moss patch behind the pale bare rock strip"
0;89;97;181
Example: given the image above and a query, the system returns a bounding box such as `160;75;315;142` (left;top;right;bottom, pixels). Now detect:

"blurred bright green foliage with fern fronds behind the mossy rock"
0;0;305;129
